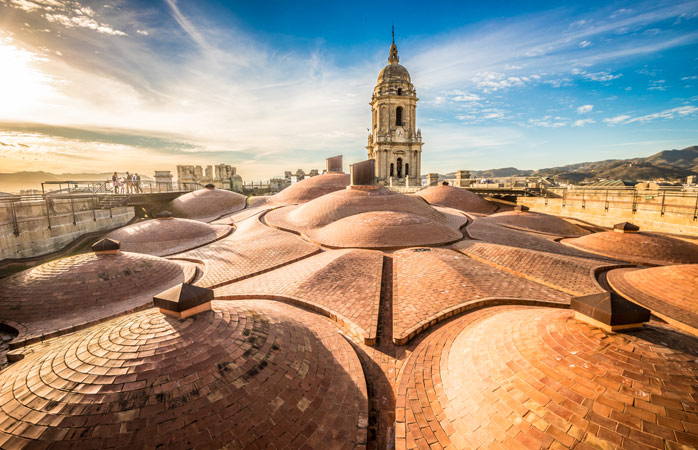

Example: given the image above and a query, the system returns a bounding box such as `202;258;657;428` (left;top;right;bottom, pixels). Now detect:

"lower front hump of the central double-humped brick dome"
305;211;456;248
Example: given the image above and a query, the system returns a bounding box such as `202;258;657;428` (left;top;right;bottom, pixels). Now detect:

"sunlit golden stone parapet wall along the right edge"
518;191;698;236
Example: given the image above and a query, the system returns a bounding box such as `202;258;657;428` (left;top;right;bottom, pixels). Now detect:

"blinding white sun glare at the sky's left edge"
0;39;51;119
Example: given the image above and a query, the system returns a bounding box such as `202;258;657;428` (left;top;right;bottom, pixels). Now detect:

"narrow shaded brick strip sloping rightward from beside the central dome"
462;217;616;259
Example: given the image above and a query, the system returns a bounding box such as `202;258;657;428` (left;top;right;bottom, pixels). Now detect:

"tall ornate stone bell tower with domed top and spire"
366;32;423;186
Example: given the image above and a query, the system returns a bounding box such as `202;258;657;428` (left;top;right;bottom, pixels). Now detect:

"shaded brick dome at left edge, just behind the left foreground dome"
0;252;195;345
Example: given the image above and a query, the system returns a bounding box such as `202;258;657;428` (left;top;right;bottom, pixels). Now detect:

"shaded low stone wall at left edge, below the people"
0;199;134;260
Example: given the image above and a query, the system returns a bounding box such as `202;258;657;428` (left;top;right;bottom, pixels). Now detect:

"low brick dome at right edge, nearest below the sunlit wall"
562;231;698;265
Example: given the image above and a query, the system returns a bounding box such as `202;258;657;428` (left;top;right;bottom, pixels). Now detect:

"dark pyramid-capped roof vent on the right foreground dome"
570;292;650;331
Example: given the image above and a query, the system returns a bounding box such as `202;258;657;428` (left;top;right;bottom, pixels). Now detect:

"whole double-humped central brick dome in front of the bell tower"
265;187;462;248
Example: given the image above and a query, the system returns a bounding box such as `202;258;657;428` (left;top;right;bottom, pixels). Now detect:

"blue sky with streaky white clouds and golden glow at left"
0;0;698;180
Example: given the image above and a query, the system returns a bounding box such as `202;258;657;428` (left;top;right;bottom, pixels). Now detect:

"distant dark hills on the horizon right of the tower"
456;145;698;183
